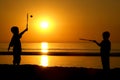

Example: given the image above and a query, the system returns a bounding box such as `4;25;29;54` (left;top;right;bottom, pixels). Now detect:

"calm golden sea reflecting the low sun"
0;42;120;68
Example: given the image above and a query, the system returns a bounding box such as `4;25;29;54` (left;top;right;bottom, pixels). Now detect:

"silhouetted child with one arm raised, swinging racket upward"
8;26;28;65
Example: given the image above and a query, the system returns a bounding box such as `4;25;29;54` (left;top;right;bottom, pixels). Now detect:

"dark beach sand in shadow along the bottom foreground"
0;64;120;80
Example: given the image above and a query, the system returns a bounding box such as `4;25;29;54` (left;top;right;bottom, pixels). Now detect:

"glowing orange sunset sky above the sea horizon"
0;0;120;42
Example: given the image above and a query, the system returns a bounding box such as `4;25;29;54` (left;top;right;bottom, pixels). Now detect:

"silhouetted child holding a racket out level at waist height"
93;31;111;71
